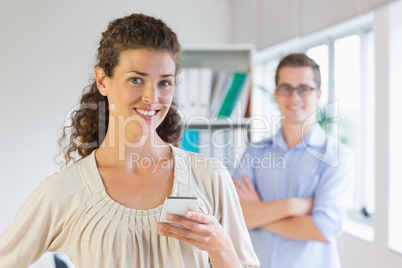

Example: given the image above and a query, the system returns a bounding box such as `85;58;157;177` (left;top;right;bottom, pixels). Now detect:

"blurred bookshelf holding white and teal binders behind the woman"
175;45;255;173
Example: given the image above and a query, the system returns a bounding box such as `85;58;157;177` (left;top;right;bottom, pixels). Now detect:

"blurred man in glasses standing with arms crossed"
233;54;354;268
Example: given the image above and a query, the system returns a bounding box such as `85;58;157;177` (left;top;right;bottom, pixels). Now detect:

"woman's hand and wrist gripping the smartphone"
157;211;241;267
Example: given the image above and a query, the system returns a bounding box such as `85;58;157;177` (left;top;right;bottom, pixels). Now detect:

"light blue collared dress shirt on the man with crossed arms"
234;123;354;268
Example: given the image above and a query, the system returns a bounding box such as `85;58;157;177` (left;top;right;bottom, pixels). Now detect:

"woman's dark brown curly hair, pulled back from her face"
58;14;183;167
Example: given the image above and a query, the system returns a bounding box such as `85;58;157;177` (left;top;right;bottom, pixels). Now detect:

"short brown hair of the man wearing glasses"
275;53;321;88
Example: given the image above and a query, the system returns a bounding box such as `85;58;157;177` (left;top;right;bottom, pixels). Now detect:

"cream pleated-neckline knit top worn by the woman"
0;146;259;268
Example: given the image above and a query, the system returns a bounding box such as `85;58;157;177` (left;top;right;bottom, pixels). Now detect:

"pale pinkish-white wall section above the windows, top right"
231;0;394;49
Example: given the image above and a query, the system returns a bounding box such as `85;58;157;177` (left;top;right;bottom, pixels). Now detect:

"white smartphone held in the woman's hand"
159;196;200;227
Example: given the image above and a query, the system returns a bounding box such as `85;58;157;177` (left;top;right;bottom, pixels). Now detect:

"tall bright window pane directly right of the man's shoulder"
334;31;374;222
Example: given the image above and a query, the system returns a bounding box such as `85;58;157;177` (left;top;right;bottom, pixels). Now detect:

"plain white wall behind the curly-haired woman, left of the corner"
0;0;230;233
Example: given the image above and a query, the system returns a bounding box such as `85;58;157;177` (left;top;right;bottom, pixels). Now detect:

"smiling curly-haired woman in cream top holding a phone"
0;14;259;268
